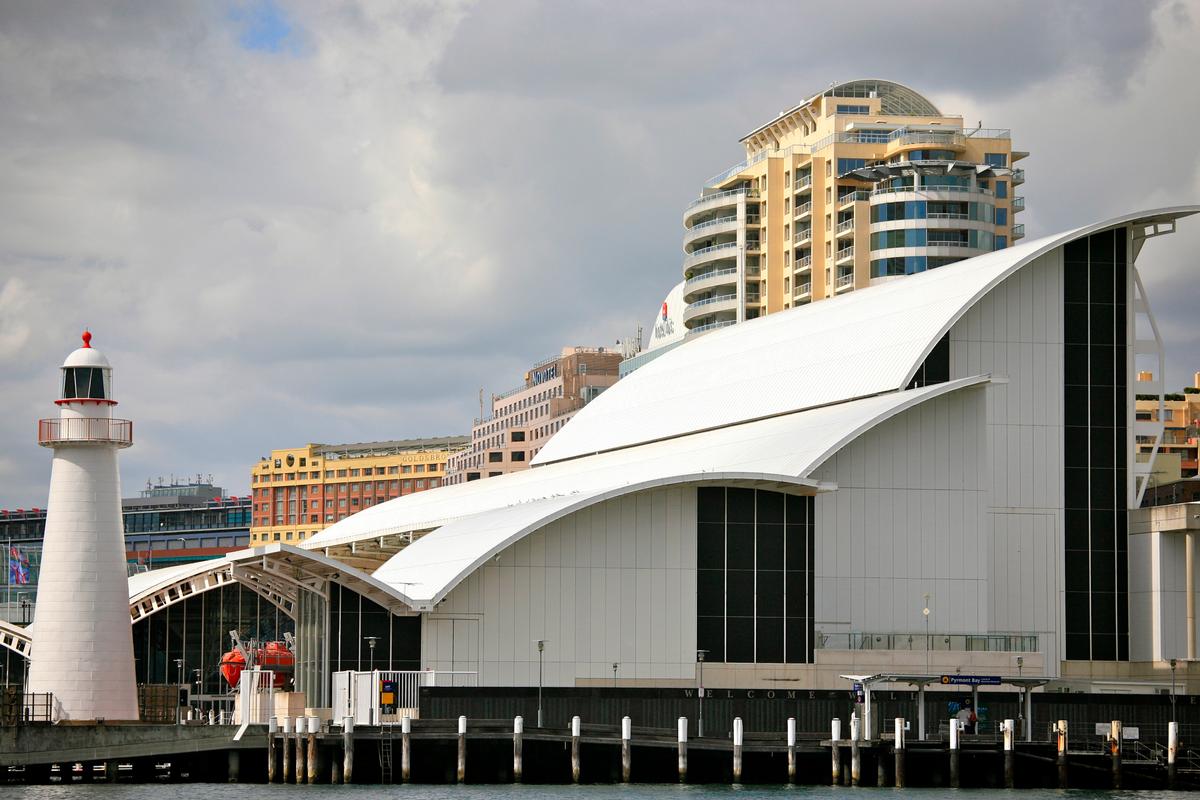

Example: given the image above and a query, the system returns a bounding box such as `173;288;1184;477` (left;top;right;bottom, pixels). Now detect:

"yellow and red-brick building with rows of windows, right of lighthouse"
250;437;468;545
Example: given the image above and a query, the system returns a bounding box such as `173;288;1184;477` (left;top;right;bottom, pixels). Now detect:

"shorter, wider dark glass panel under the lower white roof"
696;487;815;663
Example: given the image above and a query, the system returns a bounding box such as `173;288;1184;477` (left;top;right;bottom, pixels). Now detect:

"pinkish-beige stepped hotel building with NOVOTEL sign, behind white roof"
445;347;622;483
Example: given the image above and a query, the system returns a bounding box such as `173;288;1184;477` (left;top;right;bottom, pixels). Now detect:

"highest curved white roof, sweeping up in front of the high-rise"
532;206;1200;467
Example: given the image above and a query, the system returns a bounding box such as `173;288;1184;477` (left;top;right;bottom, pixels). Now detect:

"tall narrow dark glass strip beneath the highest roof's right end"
1063;228;1129;661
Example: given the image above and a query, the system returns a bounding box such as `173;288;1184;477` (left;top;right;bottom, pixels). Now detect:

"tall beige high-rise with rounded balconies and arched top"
683;80;1028;335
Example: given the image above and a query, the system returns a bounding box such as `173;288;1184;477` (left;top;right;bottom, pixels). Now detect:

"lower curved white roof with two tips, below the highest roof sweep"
333;378;986;608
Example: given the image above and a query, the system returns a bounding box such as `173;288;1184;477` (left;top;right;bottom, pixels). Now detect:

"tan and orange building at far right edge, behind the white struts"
1135;372;1200;486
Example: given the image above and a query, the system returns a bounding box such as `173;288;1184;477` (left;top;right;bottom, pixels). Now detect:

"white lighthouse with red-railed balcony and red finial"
26;331;138;720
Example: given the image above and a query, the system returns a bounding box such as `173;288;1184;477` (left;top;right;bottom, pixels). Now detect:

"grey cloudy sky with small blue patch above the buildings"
0;0;1200;507
